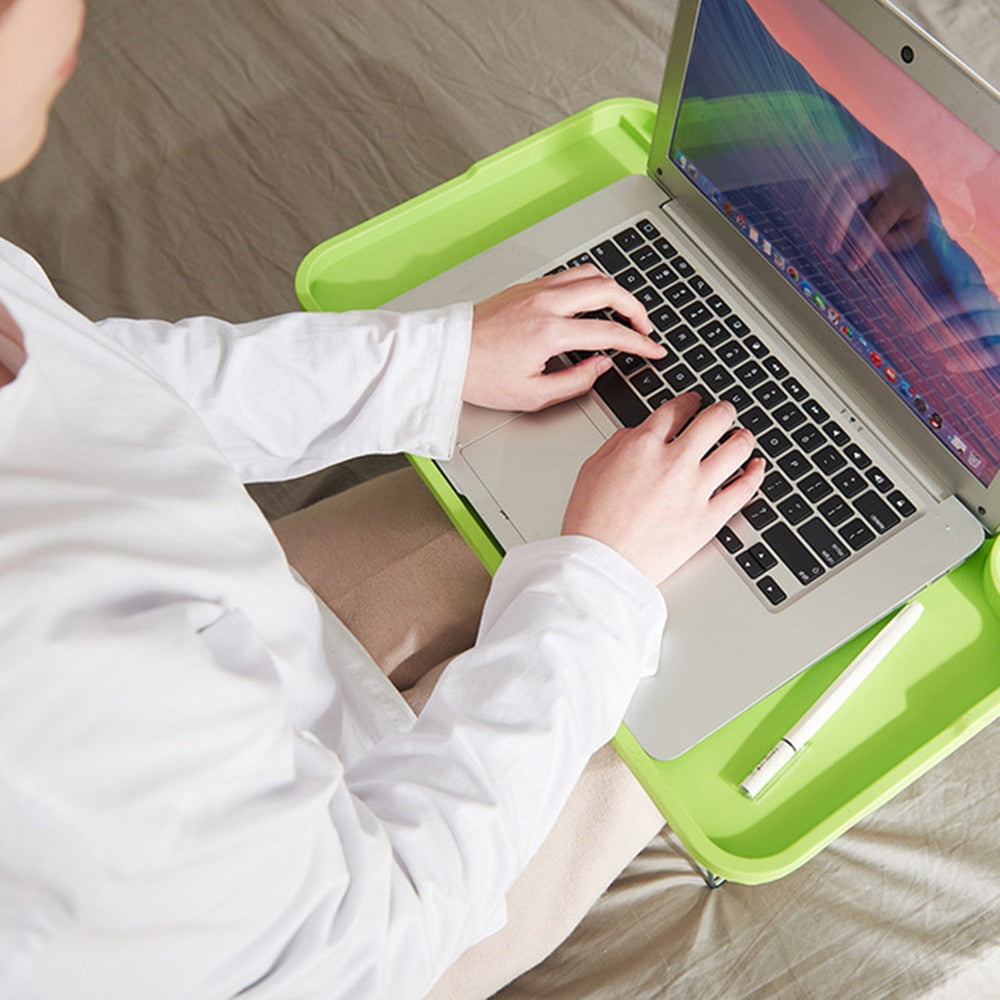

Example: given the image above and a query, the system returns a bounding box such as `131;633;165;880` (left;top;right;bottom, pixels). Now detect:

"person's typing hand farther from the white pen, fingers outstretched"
462;264;665;411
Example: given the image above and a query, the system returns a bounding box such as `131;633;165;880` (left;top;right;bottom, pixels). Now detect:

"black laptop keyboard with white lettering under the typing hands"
550;219;916;607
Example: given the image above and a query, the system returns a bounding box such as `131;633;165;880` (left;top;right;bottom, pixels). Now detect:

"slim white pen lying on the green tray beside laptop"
740;601;924;799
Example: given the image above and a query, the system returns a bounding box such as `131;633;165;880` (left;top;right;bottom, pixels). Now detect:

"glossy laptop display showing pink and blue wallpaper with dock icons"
670;0;1000;485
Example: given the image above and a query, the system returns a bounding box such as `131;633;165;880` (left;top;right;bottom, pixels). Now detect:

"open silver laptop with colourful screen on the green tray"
390;0;1000;760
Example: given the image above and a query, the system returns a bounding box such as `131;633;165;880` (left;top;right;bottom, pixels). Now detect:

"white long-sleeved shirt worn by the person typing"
0;241;665;1000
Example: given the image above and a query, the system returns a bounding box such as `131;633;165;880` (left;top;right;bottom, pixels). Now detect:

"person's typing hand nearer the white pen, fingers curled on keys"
562;393;764;583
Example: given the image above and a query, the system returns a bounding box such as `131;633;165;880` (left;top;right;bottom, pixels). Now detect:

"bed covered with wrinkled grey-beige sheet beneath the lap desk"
0;0;1000;1000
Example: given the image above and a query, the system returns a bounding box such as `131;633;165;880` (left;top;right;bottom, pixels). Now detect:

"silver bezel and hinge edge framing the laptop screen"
648;0;1000;534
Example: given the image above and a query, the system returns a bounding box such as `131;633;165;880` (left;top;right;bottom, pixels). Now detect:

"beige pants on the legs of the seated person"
274;469;663;1000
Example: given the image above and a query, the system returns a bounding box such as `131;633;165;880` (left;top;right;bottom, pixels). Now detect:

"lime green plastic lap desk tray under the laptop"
296;98;1000;883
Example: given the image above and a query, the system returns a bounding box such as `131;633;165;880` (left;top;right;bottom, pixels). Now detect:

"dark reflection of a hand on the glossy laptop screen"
819;155;929;271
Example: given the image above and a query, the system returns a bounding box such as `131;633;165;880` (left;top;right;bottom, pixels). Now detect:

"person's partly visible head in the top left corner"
0;0;84;180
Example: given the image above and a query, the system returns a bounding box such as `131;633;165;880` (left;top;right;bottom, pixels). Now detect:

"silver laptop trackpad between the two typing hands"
461;403;605;541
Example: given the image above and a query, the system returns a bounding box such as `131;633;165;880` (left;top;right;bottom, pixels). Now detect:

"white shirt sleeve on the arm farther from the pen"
97;305;472;482
